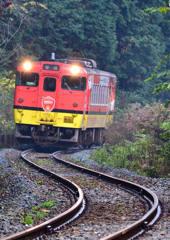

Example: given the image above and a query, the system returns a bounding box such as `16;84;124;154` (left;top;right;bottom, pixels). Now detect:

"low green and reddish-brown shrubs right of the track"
92;104;170;177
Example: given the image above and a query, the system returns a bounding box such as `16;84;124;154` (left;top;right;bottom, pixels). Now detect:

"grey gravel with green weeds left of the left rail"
0;149;71;239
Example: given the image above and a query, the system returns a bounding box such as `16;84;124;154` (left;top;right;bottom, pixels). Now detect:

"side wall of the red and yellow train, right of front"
82;75;116;130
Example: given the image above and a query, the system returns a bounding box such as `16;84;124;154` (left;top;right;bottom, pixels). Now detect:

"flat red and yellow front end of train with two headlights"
14;57;87;146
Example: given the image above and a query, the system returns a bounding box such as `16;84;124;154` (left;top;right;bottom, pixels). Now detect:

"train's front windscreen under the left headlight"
16;72;39;87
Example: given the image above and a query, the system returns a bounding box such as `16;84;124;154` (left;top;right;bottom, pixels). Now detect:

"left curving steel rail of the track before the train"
3;149;85;240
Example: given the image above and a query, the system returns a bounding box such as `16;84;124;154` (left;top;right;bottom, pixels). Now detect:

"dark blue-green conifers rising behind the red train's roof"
17;0;168;105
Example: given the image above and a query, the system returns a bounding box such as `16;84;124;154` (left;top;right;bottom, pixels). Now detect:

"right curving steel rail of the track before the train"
53;151;161;240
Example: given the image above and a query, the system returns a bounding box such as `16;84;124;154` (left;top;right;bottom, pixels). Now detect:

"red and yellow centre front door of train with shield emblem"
36;74;58;125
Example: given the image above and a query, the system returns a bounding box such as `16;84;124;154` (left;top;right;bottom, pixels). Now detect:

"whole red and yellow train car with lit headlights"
14;53;117;147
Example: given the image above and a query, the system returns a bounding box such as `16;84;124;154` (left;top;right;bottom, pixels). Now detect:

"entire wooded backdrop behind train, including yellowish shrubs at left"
0;0;170;176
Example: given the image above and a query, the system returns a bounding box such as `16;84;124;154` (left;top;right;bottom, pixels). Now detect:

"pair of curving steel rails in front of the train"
5;150;161;240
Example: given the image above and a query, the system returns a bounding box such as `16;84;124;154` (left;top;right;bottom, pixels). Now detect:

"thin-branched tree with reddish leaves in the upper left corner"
0;0;45;69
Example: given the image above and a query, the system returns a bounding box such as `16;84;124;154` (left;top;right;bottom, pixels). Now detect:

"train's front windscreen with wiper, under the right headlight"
61;76;86;91
